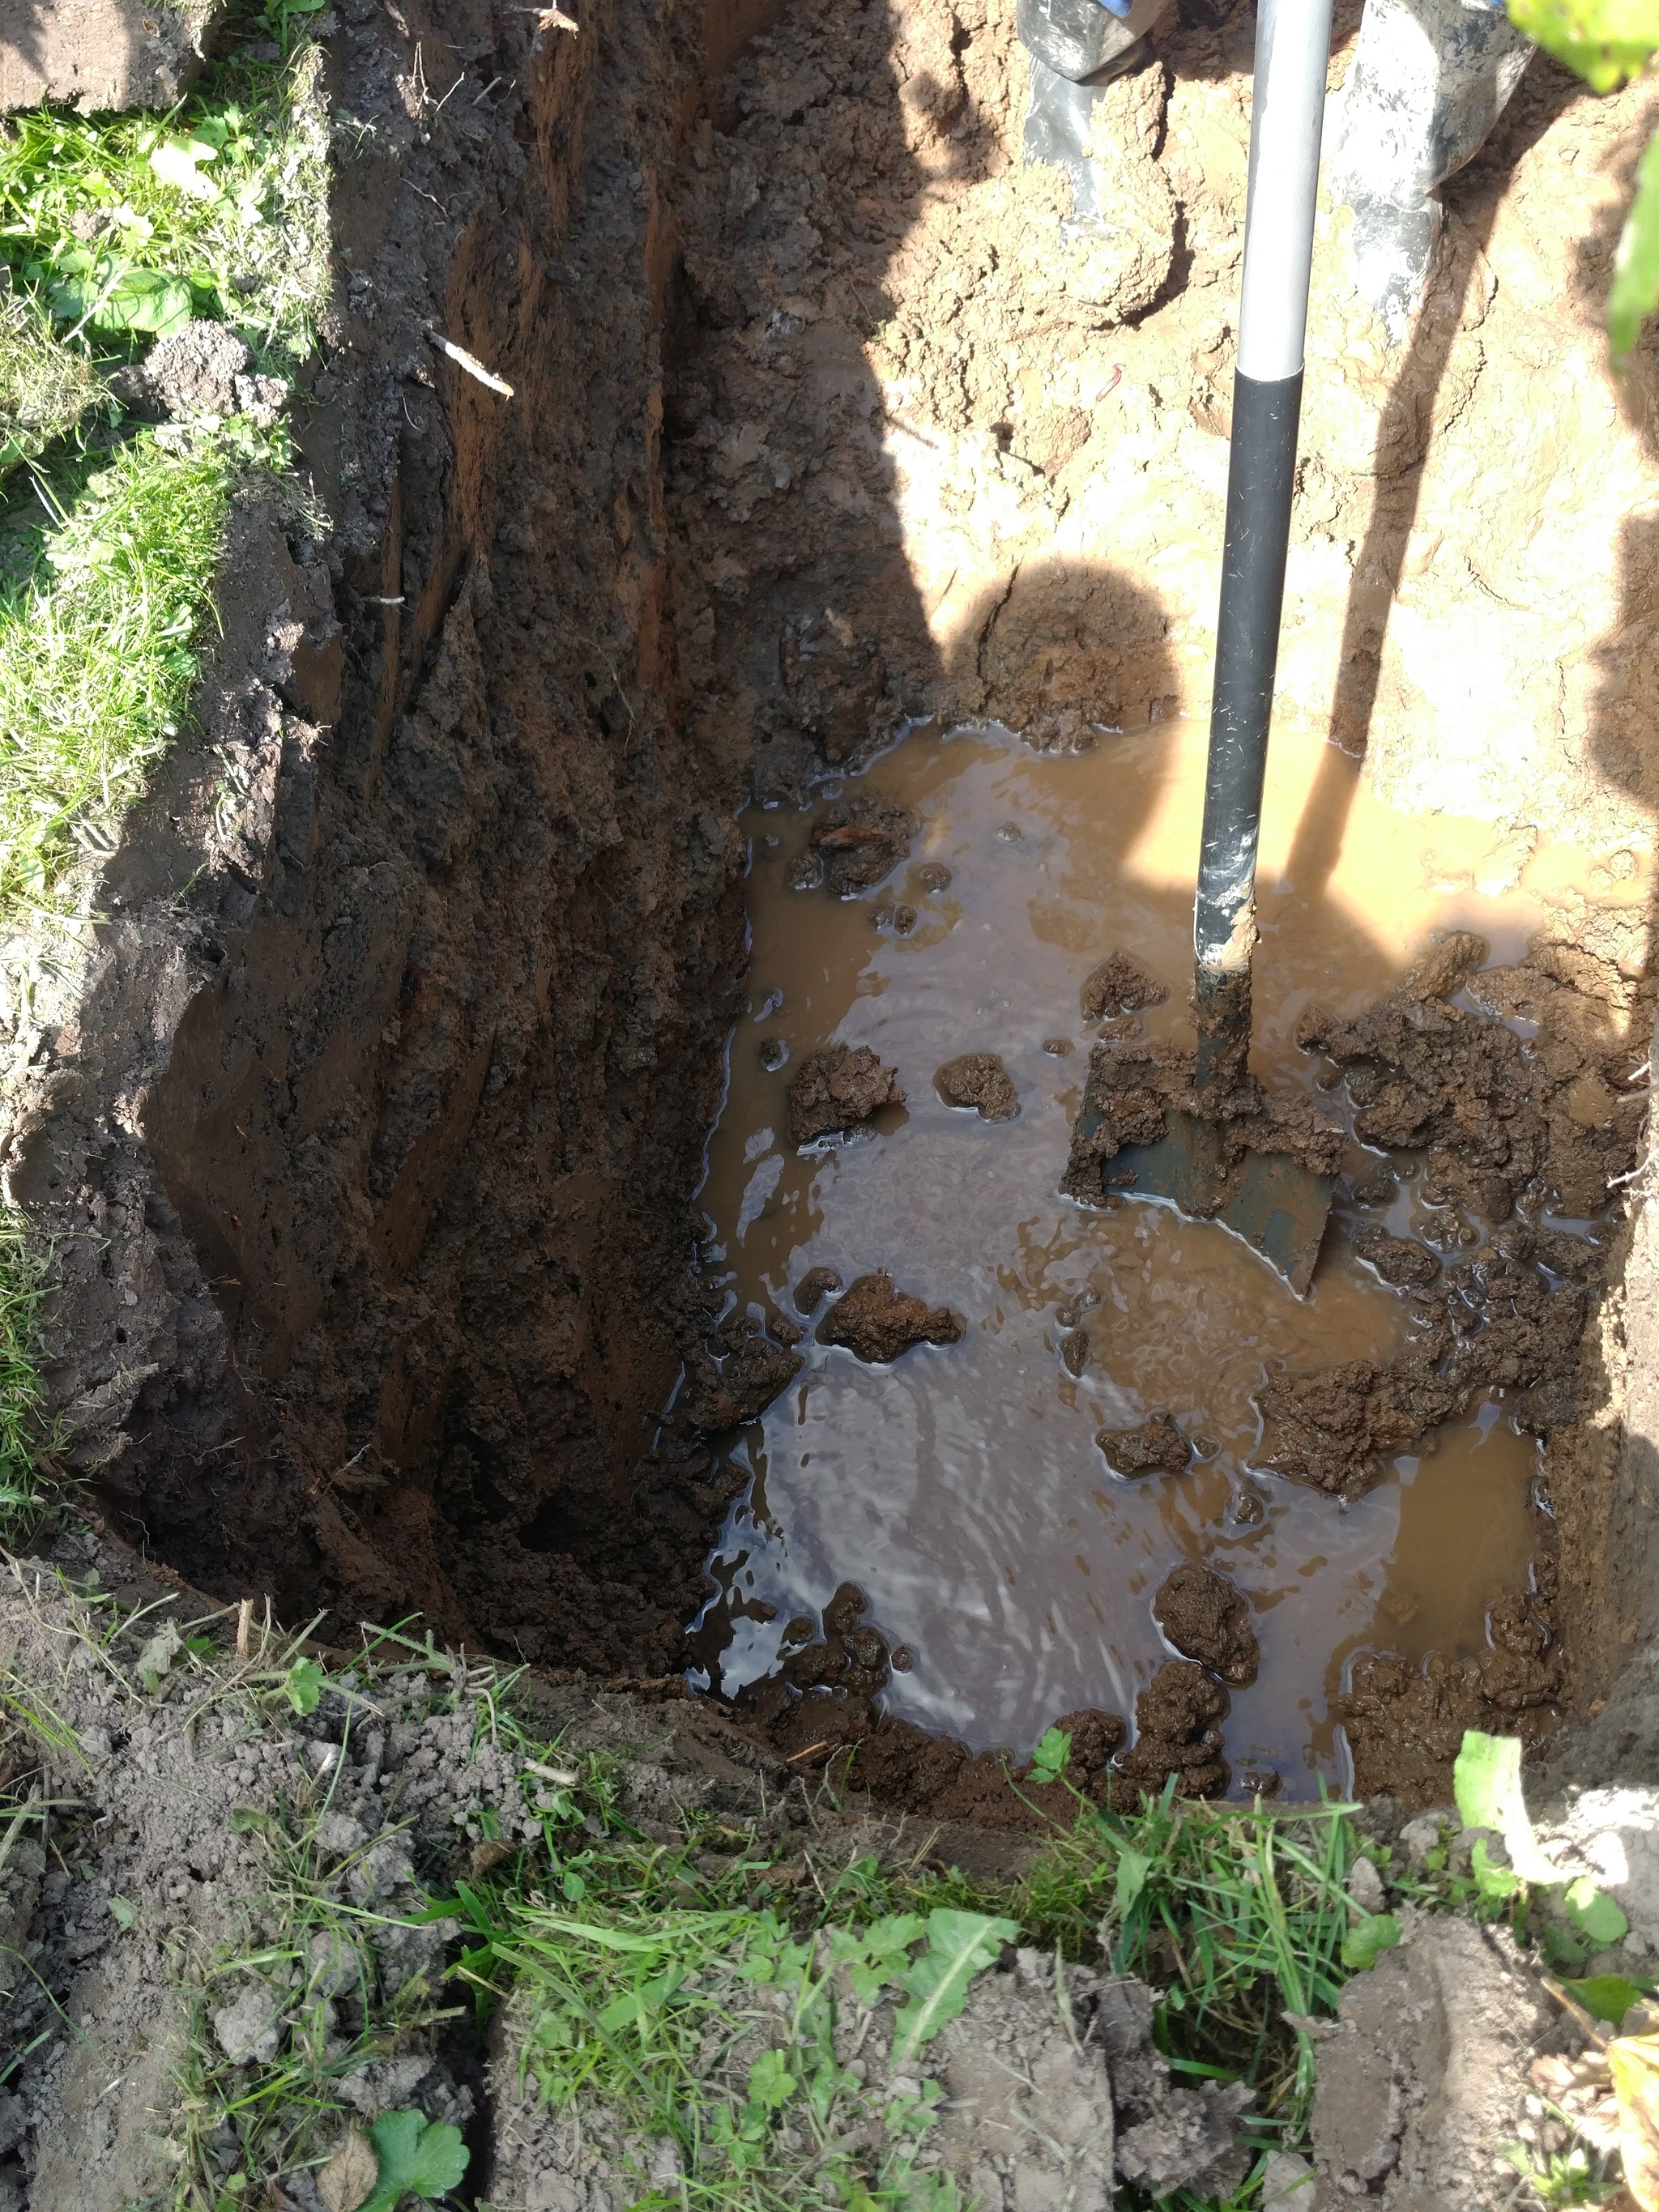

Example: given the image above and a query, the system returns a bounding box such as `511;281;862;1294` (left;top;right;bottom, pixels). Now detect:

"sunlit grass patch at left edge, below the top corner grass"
0;432;237;920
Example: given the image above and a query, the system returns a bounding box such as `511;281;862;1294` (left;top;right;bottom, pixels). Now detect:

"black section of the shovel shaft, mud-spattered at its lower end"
1192;369;1303;978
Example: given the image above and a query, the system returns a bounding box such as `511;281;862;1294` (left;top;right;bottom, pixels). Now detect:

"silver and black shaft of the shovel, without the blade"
1192;0;1332;1090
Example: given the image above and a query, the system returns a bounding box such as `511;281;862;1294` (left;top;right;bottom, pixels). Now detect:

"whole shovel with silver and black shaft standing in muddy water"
1092;0;1334;1296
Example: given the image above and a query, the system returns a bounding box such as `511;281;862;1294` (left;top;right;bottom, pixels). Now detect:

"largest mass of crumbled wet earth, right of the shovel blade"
1259;931;1653;1498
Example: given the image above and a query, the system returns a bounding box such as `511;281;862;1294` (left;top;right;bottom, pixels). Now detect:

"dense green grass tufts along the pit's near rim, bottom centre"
429;1751;1360;2212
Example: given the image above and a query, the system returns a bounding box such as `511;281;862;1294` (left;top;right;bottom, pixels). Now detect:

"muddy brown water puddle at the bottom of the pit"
699;721;1644;1796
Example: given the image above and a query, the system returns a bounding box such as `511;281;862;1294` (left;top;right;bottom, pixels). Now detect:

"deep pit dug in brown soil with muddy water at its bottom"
22;0;1659;1812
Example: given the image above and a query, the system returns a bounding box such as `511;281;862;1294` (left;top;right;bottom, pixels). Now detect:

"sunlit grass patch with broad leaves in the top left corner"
0;49;330;363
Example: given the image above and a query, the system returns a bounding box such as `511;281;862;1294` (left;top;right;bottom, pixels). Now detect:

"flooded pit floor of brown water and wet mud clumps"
693;723;1650;1825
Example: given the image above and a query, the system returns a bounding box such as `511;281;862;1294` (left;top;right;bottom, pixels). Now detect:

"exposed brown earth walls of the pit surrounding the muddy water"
4;0;1659;1803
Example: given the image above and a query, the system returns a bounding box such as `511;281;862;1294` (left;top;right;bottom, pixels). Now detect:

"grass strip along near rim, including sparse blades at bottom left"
120;1632;1363;2212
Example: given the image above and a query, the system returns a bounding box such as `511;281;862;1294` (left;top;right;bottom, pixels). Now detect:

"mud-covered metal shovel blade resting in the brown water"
1106;1108;1336;1298
